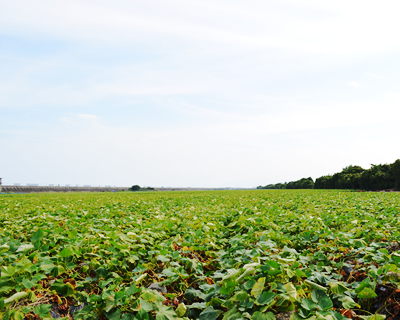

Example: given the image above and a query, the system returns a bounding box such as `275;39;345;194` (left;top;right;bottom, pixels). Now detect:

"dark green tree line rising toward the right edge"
257;159;400;191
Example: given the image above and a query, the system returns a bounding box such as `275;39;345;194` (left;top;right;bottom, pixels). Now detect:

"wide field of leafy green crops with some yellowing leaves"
0;190;400;320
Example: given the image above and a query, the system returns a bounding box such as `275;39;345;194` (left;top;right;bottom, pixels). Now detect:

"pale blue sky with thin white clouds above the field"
0;0;400;188
